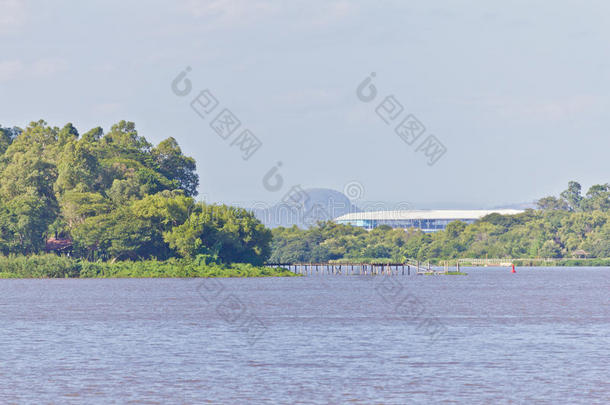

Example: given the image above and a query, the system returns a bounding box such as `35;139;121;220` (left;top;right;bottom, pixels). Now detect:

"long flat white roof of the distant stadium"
335;209;523;221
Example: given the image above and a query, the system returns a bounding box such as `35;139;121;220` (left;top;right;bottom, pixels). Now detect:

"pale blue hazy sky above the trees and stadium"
0;0;610;208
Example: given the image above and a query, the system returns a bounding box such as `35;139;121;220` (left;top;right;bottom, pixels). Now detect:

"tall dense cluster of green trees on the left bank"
0;121;271;265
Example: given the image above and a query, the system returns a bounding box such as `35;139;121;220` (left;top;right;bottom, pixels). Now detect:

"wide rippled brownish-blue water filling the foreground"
0;268;610;404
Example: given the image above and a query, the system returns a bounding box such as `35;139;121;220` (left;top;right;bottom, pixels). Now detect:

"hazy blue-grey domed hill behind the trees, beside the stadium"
252;188;361;228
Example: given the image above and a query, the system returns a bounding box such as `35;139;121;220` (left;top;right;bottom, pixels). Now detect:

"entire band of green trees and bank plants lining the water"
0;120;610;278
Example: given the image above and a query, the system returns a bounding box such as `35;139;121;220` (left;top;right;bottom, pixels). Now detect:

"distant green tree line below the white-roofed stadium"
270;182;610;263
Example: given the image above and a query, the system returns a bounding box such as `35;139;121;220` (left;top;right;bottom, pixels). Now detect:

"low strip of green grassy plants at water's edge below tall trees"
0;254;295;278
